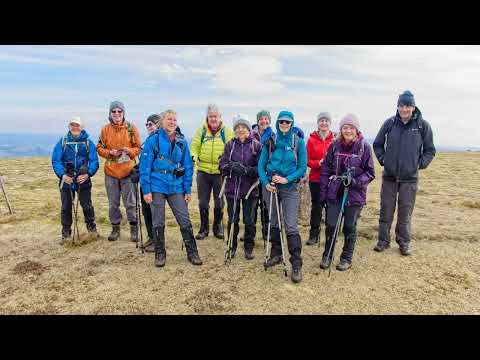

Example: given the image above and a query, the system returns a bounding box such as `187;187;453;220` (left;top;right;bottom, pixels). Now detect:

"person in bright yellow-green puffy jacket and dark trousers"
190;104;234;240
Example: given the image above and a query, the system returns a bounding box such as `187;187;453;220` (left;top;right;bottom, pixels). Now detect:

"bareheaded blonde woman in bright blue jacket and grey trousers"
140;110;202;267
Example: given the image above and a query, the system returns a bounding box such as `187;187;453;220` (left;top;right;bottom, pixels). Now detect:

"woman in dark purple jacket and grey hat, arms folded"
220;115;262;260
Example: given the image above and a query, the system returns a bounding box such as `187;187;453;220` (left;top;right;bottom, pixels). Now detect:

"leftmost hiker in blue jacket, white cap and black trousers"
52;117;98;245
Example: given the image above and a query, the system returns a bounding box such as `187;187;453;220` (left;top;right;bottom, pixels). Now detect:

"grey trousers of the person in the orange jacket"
105;175;137;225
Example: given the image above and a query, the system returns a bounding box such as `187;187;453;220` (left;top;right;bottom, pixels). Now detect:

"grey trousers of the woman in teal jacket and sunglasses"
262;184;299;236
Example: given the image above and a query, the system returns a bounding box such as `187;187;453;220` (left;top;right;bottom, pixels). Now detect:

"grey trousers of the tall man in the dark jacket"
378;179;417;246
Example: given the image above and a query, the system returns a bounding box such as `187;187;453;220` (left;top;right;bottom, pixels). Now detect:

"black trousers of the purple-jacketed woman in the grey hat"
227;198;258;249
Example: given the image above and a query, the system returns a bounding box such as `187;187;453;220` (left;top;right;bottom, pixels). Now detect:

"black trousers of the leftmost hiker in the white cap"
60;179;95;229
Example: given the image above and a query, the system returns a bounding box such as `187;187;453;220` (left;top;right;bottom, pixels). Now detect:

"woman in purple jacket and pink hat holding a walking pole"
320;114;375;271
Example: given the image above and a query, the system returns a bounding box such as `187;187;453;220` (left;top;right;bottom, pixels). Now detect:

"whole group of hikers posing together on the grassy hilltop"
52;90;436;283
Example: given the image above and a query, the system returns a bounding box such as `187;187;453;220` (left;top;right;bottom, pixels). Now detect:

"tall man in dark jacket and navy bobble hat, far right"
373;90;436;256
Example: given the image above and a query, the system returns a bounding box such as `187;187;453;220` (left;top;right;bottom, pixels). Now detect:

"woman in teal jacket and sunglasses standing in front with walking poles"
258;111;307;282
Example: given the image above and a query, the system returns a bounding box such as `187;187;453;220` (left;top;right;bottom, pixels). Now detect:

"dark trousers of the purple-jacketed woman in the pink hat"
323;199;362;263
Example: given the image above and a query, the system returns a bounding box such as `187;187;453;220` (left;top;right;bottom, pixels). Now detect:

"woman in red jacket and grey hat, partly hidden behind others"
307;112;335;245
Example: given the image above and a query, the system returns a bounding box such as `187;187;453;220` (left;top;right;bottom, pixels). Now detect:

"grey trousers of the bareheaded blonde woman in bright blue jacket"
150;193;192;229
